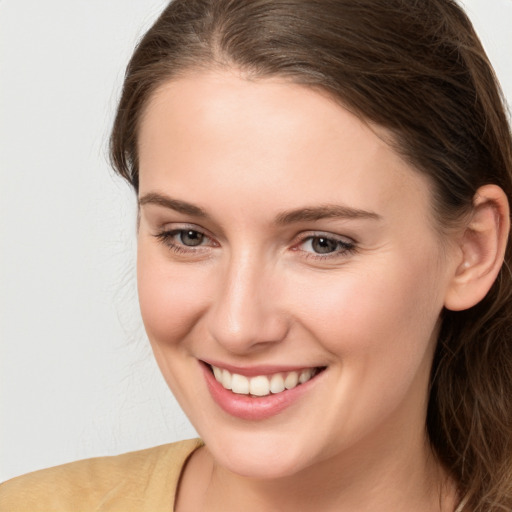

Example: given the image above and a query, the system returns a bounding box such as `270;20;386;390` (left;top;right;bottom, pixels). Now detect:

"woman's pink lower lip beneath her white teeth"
201;363;323;421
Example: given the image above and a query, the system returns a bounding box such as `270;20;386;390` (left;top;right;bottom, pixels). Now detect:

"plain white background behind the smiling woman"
0;0;512;481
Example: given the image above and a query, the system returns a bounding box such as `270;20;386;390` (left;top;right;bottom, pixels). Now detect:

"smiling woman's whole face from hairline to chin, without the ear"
138;71;453;477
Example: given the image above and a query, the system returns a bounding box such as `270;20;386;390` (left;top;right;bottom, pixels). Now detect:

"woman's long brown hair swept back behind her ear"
111;0;512;512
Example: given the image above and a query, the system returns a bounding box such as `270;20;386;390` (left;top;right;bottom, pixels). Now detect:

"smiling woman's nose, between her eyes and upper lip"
208;250;289;355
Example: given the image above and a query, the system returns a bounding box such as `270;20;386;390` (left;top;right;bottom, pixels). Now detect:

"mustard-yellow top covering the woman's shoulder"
0;439;202;512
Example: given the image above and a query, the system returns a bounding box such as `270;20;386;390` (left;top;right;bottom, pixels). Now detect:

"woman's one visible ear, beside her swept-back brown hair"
444;185;510;311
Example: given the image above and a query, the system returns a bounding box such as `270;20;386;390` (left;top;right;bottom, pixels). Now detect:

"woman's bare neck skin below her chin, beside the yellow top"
175;438;460;512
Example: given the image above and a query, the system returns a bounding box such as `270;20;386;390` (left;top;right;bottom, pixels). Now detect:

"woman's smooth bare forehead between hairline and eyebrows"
138;72;429;224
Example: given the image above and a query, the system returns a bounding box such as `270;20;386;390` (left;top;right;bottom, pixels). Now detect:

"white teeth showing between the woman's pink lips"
208;365;326;397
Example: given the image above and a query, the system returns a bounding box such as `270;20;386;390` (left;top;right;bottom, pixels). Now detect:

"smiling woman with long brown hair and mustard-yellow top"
0;0;512;512
